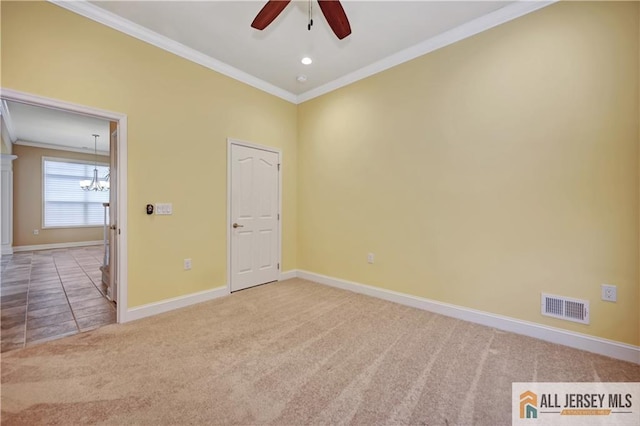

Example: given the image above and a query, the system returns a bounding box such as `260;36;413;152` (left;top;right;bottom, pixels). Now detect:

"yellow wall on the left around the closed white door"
1;1;297;307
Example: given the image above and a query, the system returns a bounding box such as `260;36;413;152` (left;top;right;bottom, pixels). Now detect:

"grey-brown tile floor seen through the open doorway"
0;246;116;352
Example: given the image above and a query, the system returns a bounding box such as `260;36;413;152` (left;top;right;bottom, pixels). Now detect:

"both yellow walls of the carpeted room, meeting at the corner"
1;1;640;345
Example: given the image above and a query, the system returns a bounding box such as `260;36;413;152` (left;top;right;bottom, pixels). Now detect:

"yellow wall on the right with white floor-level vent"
298;2;640;345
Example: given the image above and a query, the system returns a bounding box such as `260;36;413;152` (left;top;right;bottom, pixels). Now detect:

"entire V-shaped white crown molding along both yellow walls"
47;0;559;104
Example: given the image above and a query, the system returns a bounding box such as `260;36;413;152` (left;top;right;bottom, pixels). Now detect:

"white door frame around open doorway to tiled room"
0;87;128;323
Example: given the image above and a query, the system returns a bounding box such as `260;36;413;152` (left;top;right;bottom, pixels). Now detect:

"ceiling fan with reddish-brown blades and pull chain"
251;0;351;40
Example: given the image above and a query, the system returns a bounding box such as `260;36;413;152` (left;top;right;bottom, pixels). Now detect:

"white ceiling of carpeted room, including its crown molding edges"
51;0;551;103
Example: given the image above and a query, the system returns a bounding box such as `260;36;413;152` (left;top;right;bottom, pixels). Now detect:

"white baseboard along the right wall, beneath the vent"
296;270;640;364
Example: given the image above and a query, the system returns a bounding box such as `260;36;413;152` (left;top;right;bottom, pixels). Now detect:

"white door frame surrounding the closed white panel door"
226;138;283;293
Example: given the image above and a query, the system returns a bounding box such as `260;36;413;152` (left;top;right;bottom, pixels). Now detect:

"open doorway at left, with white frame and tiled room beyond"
0;89;127;351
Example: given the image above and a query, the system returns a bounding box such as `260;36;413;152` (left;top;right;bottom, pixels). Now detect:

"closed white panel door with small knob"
229;143;280;291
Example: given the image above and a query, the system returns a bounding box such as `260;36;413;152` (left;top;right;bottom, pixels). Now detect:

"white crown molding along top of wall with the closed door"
48;0;297;103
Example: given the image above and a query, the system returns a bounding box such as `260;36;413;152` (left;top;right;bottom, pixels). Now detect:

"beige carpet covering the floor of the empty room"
2;280;640;425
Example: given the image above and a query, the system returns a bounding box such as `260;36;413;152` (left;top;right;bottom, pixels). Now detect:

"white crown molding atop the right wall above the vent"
296;0;559;104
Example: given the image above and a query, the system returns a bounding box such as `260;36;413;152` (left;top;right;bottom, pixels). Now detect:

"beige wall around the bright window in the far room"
13;145;109;246
